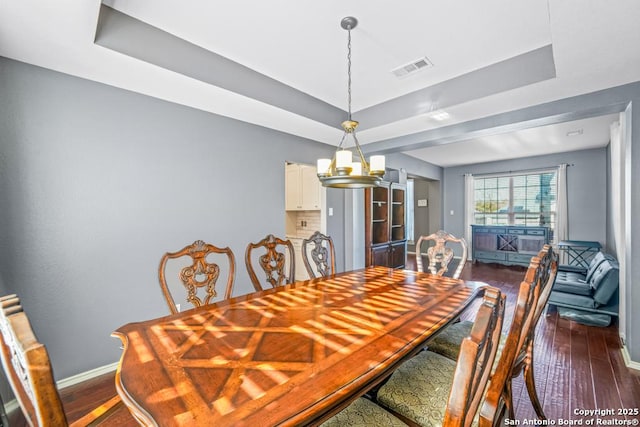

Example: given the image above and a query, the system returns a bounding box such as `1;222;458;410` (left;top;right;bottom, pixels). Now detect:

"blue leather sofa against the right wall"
549;252;620;326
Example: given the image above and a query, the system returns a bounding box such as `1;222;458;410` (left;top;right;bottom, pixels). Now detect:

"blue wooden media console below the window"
471;225;549;267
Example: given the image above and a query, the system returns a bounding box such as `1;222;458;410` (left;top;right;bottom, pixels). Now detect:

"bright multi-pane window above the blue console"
473;170;558;241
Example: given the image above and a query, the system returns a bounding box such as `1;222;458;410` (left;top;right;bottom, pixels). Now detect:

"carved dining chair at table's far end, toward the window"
416;230;468;279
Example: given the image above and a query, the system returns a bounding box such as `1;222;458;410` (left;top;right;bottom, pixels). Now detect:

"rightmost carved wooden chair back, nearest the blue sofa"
480;246;558;427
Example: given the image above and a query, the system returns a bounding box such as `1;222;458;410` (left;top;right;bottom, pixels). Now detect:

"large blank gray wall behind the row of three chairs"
0;58;344;379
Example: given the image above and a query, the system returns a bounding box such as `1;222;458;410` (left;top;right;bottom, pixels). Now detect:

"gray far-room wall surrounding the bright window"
443;148;607;247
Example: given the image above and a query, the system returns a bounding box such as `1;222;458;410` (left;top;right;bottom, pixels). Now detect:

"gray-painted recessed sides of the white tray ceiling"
95;4;556;138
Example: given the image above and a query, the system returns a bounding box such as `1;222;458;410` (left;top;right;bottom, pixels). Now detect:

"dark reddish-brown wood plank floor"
10;259;640;427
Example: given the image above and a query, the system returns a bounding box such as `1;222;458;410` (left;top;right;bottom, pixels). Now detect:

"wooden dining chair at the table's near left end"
0;295;127;427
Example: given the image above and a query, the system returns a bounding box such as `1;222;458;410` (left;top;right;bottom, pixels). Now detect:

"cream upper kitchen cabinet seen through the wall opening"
285;163;322;211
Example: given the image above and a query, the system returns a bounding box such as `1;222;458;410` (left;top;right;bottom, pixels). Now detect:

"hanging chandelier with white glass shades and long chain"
318;16;385;188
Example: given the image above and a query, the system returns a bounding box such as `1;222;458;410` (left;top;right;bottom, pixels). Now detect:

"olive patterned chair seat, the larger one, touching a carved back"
378;351;456;426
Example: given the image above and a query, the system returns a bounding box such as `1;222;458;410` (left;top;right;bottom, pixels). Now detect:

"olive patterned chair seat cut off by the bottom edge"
321;397;406;427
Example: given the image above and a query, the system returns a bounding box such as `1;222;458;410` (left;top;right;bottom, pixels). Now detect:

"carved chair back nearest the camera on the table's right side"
442;287;506;426
